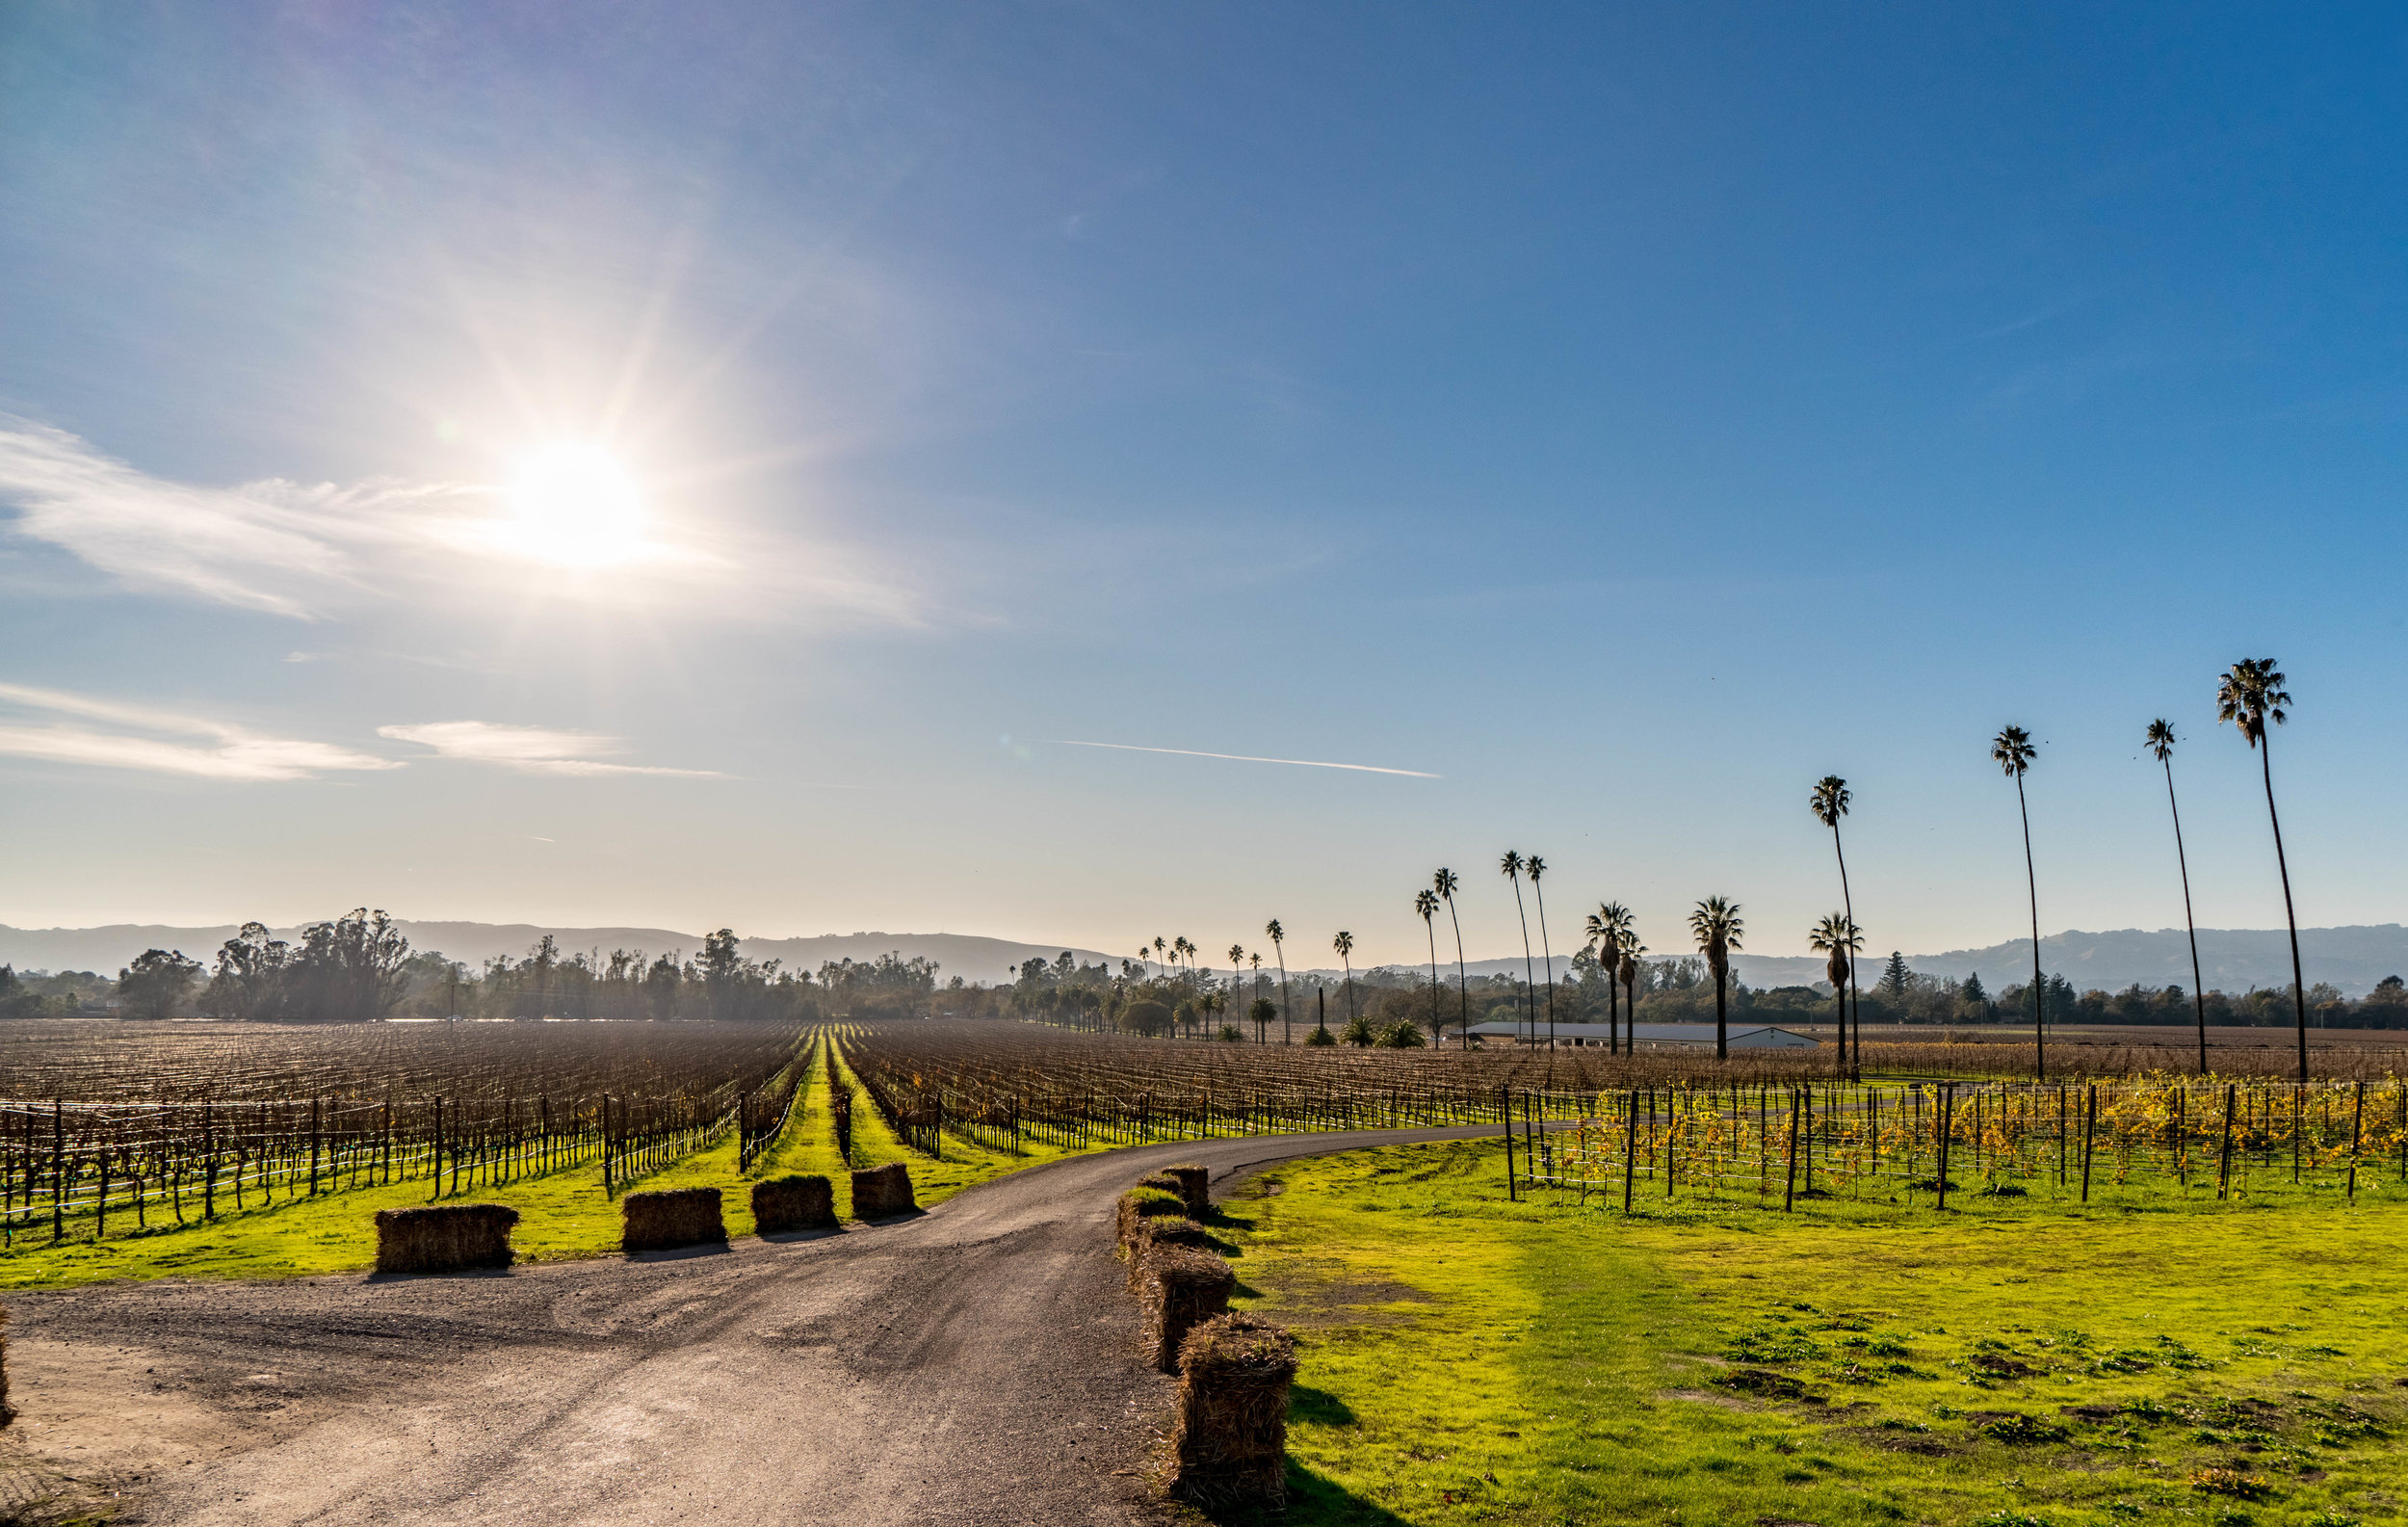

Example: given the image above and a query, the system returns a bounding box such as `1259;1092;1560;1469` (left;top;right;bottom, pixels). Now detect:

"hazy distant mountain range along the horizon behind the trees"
0;920;2408;997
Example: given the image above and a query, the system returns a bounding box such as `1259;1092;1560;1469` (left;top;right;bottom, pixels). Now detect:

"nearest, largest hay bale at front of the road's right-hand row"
1170;1315;1296;1508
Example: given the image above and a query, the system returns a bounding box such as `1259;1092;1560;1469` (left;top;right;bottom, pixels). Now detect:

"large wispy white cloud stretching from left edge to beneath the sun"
0;414;923;624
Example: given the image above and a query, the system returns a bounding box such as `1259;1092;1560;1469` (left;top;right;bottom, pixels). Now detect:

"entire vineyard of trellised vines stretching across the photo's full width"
0;1021;2408;1246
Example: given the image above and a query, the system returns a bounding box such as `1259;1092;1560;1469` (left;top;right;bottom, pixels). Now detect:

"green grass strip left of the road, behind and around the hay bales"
0;1045;1098;1289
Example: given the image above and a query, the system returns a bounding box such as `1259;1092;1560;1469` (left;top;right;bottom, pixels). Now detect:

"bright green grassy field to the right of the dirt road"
1228;1142;2408;1527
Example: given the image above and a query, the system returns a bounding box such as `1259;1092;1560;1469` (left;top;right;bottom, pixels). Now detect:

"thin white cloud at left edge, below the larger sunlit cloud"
0;684;400;780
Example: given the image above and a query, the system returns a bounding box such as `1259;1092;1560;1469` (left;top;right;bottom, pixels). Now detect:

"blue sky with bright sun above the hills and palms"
0;5;2408;959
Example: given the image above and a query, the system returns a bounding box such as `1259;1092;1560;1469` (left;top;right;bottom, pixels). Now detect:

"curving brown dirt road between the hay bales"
0;1127;1493;1527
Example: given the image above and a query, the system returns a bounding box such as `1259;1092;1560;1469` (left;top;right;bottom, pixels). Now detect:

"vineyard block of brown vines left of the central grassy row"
0;1021;809;1246
